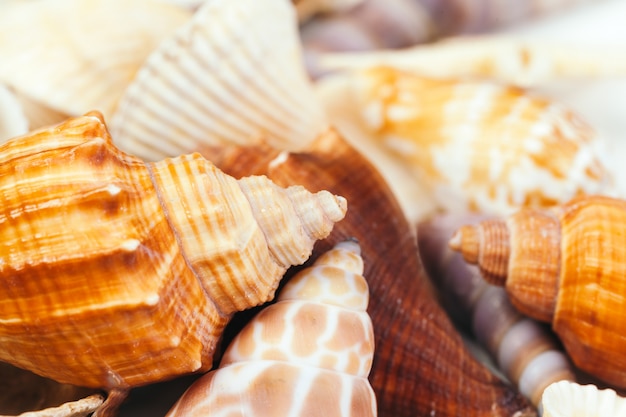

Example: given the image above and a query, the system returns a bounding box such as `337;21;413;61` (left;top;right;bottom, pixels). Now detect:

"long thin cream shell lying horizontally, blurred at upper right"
315;34;626;87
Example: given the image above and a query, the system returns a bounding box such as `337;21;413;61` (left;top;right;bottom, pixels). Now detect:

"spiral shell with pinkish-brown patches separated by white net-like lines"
168;241;376;417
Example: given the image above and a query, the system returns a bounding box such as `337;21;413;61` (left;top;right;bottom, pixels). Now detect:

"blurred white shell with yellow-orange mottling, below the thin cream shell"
319;67;612;220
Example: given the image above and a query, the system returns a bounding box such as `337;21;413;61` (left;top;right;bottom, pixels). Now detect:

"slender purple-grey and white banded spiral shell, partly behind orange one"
417;215;576;406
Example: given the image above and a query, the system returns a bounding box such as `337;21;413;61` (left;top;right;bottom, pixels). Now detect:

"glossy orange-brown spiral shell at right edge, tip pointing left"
450;196;626;387
